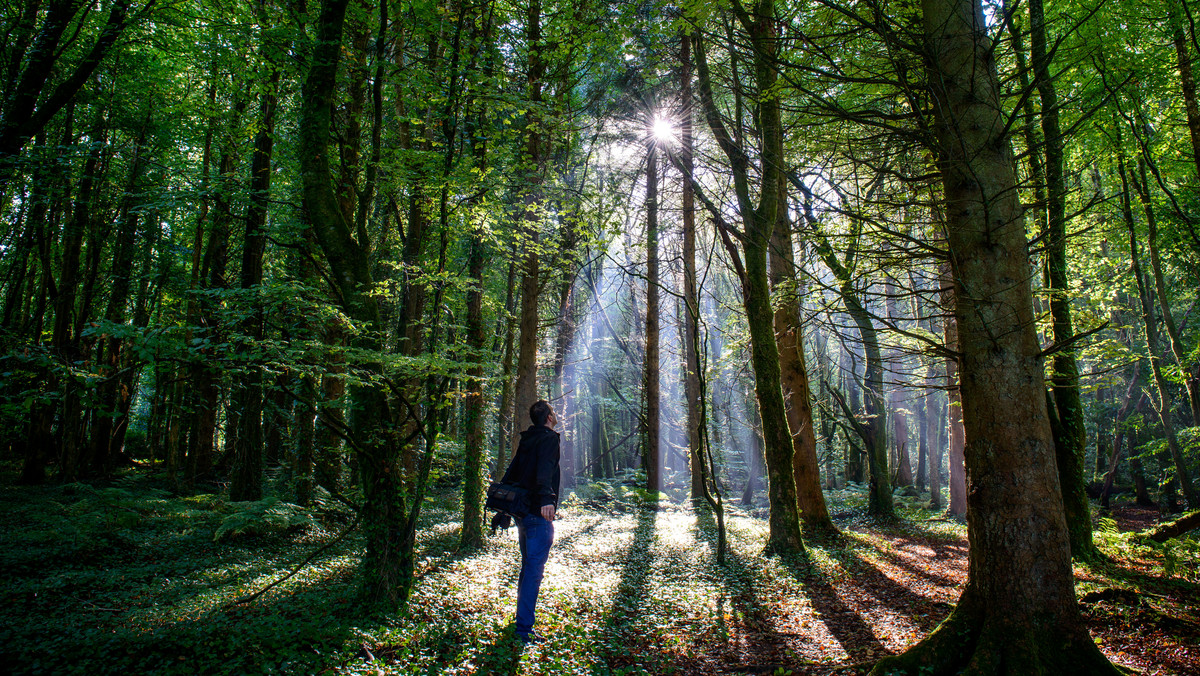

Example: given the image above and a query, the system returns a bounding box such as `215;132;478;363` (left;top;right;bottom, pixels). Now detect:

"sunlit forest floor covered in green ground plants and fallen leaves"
0;473;1200;675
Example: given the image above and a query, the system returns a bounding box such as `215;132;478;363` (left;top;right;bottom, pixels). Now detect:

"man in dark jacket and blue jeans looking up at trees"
503;400;560;644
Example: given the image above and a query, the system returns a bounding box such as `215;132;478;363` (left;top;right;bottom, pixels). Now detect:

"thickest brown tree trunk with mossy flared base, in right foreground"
871;0;1120;676
